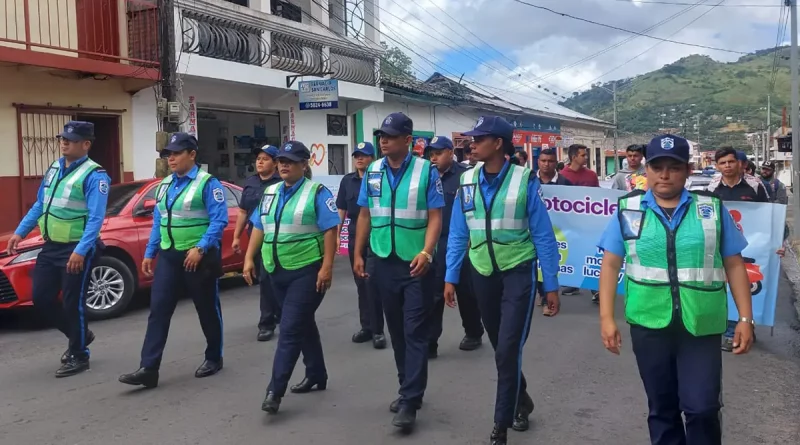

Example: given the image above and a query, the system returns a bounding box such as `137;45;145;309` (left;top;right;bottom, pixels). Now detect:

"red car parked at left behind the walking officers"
0;179;247;320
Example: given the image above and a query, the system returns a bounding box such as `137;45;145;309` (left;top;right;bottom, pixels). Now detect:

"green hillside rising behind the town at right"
562;47;791;150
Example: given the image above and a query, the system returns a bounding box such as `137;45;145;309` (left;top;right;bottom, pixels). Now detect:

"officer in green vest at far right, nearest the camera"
598;135;753;445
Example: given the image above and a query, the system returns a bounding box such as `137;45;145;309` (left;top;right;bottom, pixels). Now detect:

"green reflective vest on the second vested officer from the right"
461;165;536;277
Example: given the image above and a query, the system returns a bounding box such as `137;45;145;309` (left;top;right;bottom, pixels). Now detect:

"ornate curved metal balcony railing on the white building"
176;0;380;85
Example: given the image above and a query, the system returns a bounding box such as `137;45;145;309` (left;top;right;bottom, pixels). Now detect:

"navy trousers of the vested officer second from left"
140;249;222;369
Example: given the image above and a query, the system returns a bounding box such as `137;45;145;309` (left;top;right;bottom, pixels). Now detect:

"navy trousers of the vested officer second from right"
472;263;535;428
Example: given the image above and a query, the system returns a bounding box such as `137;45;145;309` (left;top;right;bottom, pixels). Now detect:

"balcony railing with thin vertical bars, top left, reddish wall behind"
0;0;159;72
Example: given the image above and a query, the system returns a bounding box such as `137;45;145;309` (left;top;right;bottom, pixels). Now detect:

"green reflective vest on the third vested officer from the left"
259;179;325;273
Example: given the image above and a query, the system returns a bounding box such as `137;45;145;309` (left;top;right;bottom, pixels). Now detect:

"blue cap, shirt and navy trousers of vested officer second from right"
445;116;559;444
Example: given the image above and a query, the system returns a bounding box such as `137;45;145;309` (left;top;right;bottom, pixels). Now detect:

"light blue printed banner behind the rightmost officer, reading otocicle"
542;185;786;326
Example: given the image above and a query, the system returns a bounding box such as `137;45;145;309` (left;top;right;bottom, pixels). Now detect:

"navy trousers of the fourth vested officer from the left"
369;256;436;408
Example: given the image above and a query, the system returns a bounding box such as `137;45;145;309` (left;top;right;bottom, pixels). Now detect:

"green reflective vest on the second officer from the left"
156;169;211;251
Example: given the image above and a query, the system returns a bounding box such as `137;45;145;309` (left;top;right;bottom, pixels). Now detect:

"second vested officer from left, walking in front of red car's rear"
119;133;228;388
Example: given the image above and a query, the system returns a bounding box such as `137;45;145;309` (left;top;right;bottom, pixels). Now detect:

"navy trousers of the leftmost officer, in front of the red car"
33;241;95;358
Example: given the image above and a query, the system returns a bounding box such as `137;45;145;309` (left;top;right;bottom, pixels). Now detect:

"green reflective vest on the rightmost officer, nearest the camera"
619;191;728;336
